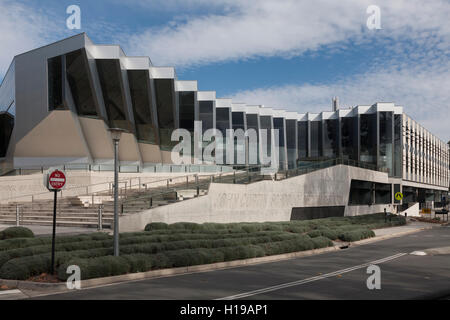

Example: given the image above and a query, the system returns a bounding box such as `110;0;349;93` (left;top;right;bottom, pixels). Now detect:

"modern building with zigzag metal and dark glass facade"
0;33;449;211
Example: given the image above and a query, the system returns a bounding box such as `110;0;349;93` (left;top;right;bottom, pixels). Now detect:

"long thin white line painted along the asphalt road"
215;253;406;300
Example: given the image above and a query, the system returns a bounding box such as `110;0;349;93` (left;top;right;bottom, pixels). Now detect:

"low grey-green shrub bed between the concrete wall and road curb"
0;214;405;280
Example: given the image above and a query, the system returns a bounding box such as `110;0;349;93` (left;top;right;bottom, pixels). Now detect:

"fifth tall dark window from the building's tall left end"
154;79;176;150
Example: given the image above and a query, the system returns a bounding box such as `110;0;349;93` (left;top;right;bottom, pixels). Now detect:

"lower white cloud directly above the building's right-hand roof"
232;61;450;141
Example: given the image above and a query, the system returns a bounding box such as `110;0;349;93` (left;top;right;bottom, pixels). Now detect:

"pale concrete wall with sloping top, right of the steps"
119;165;388;232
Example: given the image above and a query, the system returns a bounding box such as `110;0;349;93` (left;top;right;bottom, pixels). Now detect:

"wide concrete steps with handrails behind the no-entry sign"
0;176;221;228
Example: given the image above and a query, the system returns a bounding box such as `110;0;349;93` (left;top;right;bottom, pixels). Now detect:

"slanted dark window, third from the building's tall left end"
96;59;131;131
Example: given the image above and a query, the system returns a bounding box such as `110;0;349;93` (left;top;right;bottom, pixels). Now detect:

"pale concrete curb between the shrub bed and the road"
0;227;432;296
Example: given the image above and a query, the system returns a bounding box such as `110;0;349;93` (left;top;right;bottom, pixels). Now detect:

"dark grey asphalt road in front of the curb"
36;227;450;300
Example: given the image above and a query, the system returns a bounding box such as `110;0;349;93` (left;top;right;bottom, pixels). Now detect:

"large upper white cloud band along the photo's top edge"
123;0;450;66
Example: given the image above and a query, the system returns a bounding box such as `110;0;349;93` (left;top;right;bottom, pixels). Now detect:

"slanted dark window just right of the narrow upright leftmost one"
66;49;97;116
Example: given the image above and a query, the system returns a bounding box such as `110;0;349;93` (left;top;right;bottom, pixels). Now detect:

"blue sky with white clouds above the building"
0;0;450;141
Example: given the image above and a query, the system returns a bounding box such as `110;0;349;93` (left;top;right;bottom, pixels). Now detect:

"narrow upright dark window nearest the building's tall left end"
47;56;65;111
